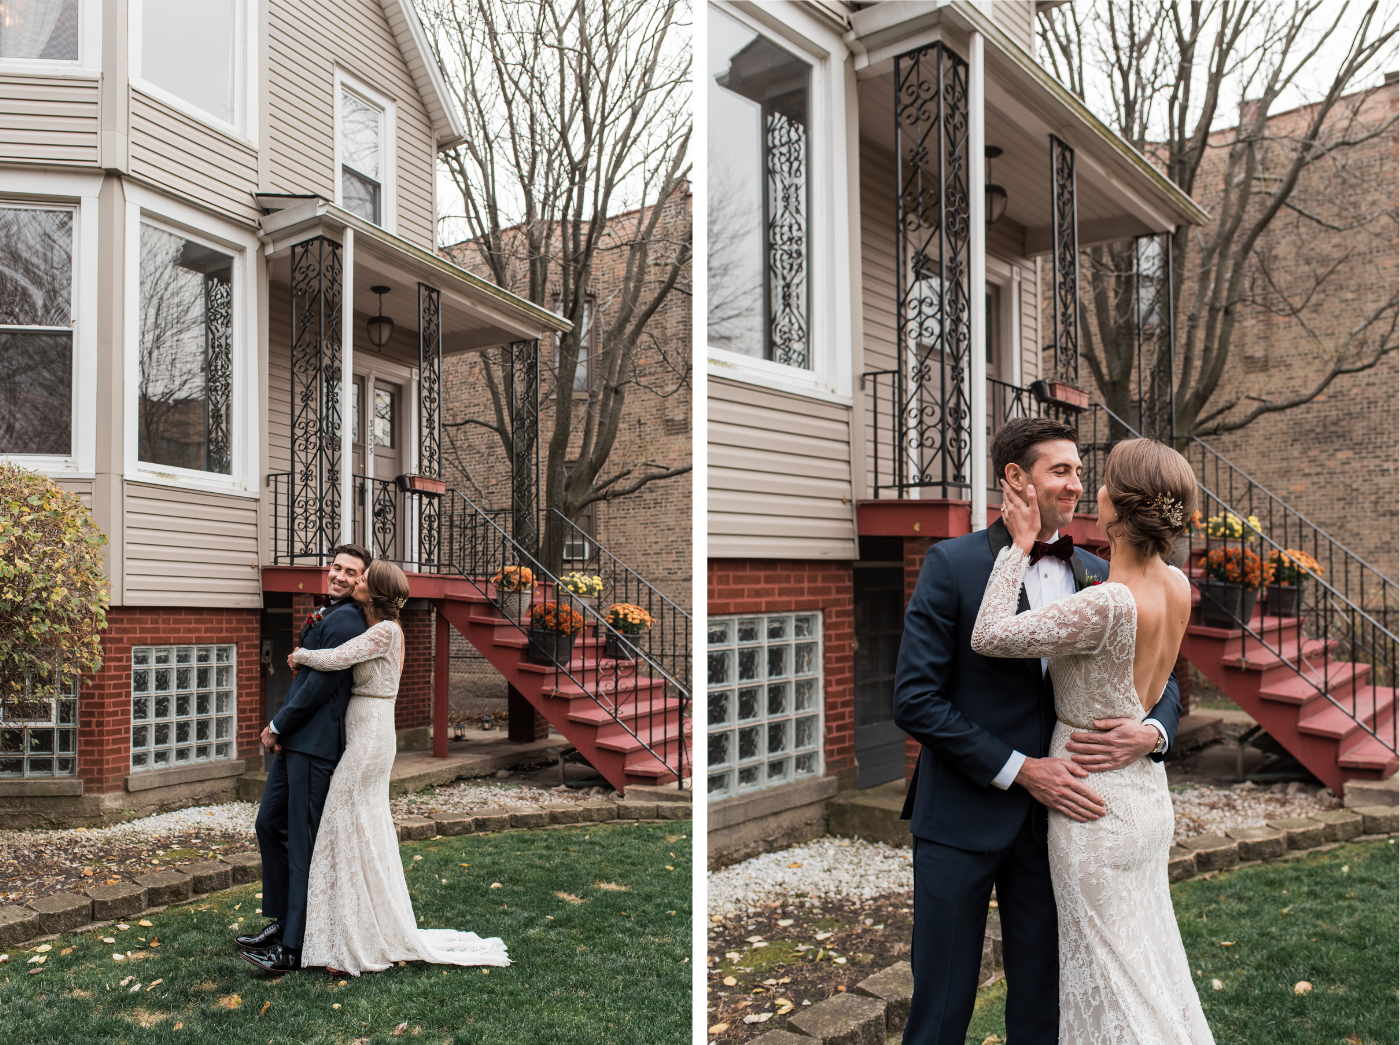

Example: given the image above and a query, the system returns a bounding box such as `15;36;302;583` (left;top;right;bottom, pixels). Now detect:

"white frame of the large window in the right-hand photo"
706;0;860;406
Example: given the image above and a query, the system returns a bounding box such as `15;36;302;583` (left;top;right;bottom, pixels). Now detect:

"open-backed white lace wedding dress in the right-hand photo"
972;545;1214;1045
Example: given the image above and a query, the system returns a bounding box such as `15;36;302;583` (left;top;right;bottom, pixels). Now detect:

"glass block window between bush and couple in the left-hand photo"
132;646;238;772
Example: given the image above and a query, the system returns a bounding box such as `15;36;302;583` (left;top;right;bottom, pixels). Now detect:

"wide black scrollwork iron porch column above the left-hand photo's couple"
288;235;343;563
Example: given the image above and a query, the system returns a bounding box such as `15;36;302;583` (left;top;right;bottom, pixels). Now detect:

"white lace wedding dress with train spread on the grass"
293;621;511;976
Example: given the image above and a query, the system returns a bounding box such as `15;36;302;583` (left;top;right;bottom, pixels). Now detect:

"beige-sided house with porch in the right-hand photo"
706;0;1205;861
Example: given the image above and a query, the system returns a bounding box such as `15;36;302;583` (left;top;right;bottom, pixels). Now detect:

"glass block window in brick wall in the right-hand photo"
707;614;822;798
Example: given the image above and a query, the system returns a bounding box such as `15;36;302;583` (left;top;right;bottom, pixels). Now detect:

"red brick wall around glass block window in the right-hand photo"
706;559;857;789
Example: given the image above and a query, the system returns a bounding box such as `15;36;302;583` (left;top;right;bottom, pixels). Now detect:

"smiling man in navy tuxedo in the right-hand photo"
895;417;1180;1045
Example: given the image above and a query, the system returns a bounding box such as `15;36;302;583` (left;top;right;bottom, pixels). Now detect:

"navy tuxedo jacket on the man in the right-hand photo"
895;520;1182;853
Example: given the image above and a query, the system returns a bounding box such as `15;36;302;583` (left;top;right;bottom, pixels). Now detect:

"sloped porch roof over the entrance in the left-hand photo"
259;195;573;353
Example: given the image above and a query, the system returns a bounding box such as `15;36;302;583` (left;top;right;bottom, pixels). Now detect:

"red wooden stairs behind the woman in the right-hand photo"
1182;585;1400;794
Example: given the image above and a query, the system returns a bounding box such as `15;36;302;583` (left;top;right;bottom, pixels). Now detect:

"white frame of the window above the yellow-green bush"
0;171;102;479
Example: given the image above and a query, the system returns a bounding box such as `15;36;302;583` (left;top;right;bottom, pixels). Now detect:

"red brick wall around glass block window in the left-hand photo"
78;607;263;794
